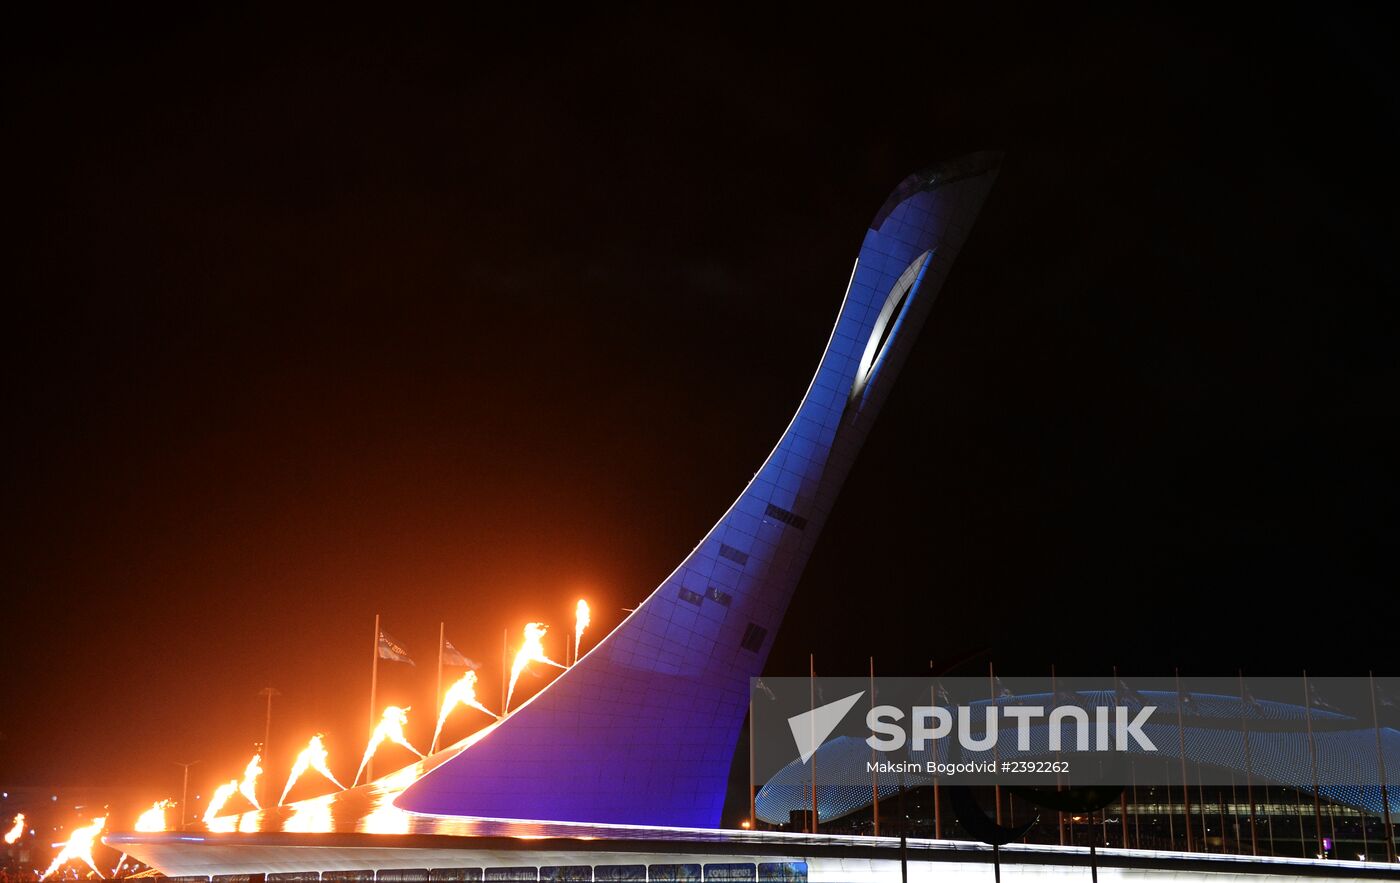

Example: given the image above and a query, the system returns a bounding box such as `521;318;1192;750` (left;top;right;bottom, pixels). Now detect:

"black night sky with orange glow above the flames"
0;4;1400;798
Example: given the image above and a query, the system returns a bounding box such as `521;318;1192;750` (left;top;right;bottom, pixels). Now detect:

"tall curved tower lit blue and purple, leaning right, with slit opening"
396;154;998;827
